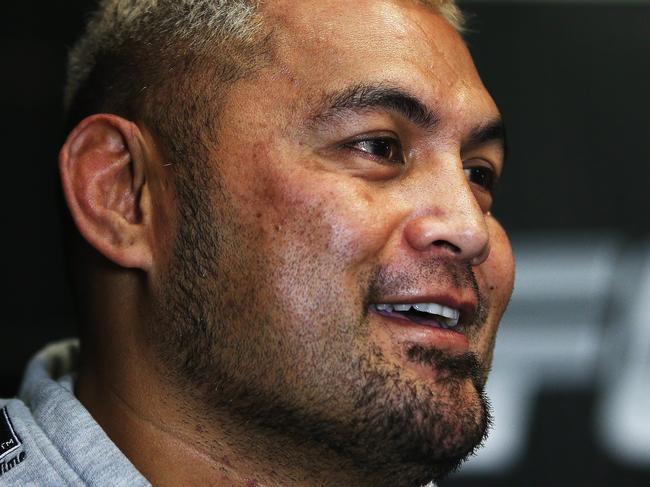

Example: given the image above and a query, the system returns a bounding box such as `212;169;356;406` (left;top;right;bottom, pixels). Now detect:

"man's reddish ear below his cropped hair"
59;115;153;271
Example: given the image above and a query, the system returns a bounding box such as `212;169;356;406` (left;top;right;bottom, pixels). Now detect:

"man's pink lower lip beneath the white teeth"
370;307;469;353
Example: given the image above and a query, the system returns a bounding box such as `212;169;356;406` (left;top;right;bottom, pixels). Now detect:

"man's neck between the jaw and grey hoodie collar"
76;340;368;487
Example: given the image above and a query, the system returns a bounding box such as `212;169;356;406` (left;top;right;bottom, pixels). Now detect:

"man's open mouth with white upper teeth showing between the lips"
371;303;460;331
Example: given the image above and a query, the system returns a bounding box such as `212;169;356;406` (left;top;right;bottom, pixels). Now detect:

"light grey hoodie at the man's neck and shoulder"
0;340;151;487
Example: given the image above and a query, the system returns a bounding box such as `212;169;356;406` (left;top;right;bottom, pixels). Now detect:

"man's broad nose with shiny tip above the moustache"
404;177;490;266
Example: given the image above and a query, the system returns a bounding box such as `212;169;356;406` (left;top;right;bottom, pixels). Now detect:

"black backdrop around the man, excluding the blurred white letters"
0;0;650;486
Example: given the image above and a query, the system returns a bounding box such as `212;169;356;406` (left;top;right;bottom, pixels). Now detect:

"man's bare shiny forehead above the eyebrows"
266;0;497;124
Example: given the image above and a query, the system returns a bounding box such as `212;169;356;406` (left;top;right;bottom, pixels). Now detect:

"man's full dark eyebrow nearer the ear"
309;84;438;130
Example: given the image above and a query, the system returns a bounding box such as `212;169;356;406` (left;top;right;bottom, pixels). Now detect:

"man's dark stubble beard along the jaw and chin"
151;170;491;487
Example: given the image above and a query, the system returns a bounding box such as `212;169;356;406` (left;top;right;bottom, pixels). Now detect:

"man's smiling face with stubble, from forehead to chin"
151;0;514;485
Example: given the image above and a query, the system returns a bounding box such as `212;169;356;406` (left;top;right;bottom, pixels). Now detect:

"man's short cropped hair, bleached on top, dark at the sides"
64;0;269;164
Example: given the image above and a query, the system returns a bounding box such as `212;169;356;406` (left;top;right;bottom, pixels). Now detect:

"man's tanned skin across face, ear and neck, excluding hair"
62;0;514;486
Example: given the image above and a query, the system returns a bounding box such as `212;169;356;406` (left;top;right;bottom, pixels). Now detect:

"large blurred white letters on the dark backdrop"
460;234;650;475
